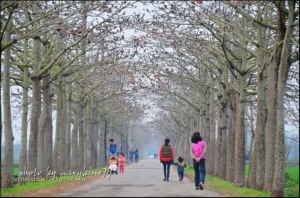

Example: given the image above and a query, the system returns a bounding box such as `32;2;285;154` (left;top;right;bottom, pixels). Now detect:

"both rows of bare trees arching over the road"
1;1;299;196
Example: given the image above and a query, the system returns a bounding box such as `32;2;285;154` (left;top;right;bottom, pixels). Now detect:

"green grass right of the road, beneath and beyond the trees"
185;166;299;197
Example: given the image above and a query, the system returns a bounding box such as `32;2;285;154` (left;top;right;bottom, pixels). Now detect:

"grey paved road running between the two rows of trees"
52;159;222;197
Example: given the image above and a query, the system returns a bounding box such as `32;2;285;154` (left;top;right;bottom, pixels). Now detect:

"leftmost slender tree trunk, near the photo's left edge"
1;13;14;188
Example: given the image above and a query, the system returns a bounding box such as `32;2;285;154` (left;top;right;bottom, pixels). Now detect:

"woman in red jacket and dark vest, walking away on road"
159;138;174;181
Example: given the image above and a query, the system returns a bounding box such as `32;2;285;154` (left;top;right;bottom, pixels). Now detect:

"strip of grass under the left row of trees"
1;166;107;197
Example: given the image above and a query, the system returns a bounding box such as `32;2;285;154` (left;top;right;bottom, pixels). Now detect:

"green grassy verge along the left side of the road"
1;167;107;197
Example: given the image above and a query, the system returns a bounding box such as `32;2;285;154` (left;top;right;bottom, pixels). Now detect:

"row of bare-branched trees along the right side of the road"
125;1;299;196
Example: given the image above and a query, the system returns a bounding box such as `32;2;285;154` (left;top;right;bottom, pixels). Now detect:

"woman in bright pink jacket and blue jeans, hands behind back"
191;132;206;190
